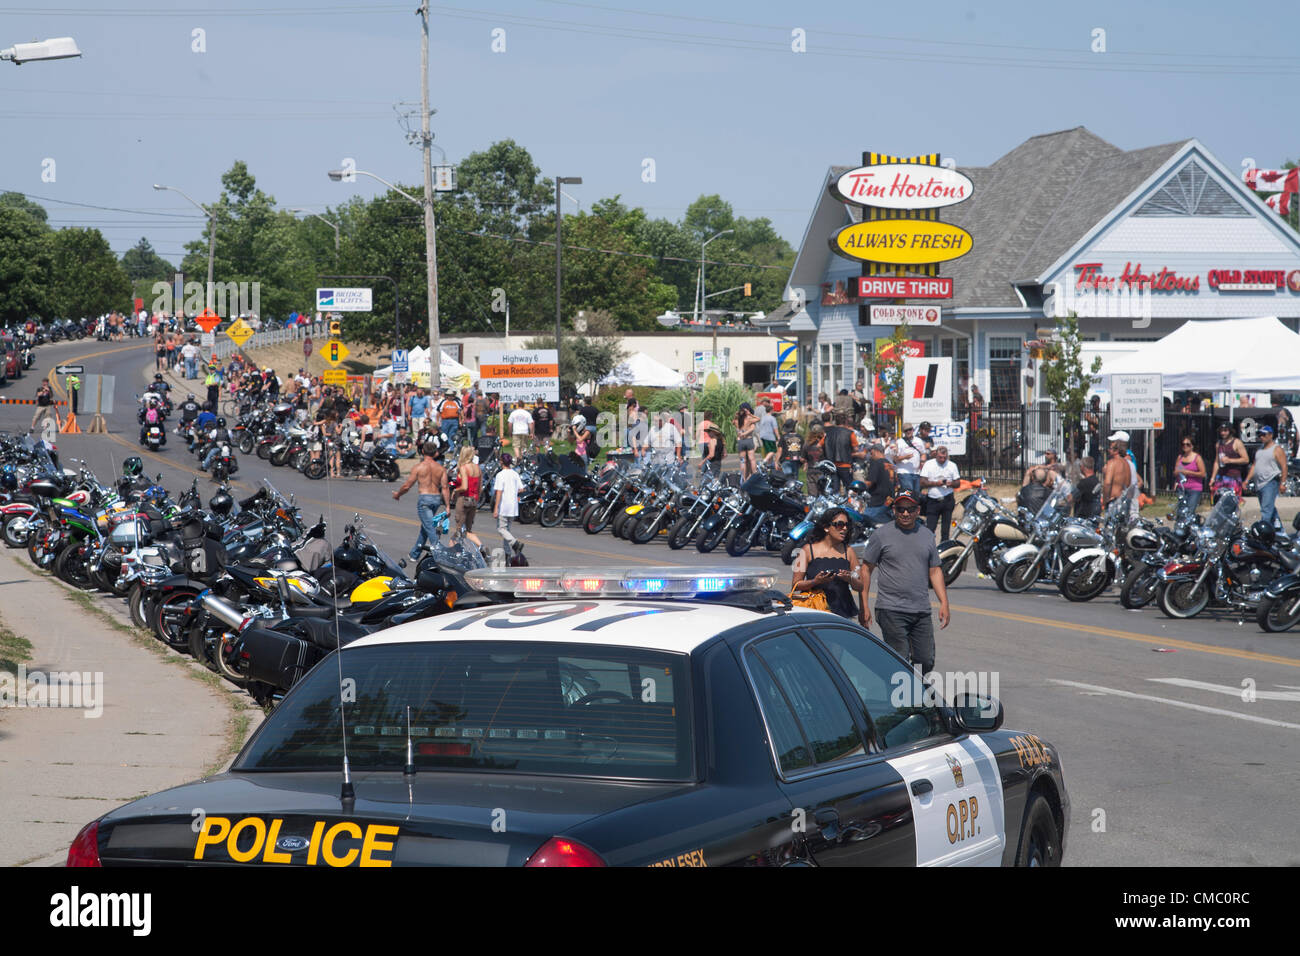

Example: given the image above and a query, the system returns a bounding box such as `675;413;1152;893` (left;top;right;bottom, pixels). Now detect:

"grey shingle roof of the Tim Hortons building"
831;126;1186;308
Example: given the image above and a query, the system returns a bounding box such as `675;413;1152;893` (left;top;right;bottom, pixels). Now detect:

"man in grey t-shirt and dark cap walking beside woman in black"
862;490;949;674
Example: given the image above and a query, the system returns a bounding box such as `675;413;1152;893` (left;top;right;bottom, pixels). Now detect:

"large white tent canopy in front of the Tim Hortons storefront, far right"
1101;316;1300;392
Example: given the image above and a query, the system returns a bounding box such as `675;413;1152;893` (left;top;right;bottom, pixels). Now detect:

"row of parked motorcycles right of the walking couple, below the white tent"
920;480;1300;632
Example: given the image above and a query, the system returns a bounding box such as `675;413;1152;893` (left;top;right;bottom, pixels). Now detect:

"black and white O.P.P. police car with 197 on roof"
68;567;1070;866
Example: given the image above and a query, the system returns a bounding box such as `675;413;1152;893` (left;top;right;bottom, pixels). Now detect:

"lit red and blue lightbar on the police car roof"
465;567;776;598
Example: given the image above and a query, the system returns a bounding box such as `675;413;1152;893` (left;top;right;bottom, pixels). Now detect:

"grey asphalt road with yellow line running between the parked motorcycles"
0;341;1300;866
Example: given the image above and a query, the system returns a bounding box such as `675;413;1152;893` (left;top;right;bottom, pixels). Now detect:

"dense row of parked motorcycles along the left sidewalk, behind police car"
0;436;499;706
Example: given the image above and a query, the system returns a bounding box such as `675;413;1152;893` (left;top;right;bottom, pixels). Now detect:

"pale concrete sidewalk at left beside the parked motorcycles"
0;549;261;866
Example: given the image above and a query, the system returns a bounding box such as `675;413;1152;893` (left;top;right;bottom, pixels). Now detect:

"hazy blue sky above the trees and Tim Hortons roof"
0;0;1300;263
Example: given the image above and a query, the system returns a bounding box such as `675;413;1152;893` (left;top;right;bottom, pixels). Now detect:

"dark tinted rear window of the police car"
234;641;694;780
